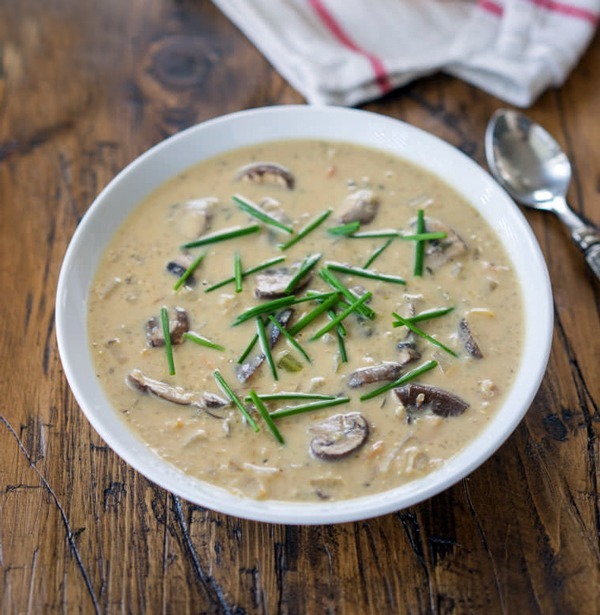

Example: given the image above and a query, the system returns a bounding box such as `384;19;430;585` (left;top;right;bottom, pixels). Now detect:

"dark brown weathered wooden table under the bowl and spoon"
0;0;600;614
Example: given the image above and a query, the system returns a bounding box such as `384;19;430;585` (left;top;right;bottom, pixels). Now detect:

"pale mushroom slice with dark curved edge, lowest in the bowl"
308;412;369;461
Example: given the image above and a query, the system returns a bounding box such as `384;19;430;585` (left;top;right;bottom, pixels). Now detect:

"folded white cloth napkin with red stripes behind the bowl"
213;0;600;107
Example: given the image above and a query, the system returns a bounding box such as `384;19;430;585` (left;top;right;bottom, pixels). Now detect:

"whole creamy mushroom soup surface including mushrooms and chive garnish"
88;140;522;502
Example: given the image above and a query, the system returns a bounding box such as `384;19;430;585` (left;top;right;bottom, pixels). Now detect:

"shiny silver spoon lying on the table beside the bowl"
485;109;600;280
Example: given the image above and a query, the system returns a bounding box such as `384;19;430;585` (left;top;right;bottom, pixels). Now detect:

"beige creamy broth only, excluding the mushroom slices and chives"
89;141;522;501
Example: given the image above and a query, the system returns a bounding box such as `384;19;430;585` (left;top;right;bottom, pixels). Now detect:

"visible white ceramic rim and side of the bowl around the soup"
56;106;553;524
